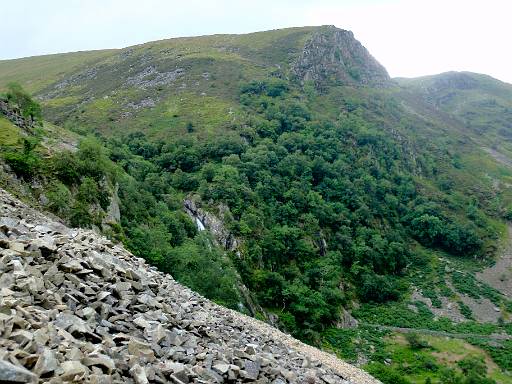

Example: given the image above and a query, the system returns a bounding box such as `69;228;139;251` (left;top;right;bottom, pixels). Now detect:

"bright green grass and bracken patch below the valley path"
323;326;512;384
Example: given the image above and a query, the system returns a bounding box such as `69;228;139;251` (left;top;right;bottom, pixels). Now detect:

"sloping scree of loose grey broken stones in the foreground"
0;190;378;384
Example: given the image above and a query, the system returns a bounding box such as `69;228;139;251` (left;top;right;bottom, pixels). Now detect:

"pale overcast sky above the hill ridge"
0;0;512;83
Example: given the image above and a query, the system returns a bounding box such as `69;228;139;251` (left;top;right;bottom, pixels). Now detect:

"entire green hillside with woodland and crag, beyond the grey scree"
0;26;512;384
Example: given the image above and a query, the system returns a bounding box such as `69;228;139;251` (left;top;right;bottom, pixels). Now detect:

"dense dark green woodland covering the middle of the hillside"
5;79;500;324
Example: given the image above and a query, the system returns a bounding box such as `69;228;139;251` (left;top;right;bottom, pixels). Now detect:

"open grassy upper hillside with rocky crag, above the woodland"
0;27;389;137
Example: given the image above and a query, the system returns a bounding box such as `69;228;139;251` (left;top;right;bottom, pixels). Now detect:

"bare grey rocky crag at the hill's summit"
292;26;391;88
